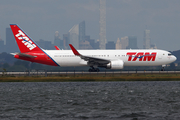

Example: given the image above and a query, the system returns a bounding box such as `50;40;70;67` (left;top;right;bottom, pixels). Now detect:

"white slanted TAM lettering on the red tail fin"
15;30;36;50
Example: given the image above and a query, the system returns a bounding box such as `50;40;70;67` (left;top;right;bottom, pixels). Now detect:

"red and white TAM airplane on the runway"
10;24;176;72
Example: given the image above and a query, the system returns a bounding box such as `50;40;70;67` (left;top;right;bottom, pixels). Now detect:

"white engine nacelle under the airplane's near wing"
106;60;124;69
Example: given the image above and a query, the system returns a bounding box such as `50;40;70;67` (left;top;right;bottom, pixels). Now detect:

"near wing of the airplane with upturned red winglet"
69;44;110;65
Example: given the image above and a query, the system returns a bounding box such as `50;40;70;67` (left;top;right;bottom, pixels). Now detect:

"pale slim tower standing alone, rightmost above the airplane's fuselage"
143;30;151;49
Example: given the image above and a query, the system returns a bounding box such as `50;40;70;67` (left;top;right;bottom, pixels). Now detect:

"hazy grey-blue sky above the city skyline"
0;0;180;51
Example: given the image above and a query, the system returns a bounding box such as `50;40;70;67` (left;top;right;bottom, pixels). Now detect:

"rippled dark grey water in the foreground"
0;82;180;120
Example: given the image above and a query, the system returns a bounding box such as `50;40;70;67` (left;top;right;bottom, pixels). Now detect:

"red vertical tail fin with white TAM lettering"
10;24;42;53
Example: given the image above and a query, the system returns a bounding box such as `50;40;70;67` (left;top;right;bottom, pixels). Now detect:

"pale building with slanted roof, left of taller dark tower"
68;24;79;49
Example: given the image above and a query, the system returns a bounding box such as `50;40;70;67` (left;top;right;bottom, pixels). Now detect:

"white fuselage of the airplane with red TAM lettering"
44;49;176;66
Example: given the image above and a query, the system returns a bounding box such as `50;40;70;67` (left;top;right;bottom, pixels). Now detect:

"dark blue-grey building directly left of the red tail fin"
5;28;19;53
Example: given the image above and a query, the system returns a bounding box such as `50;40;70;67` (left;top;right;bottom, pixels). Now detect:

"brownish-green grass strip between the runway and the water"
0;74;180;82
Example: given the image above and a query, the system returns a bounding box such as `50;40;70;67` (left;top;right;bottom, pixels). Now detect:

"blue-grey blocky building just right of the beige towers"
127;36;138;49
